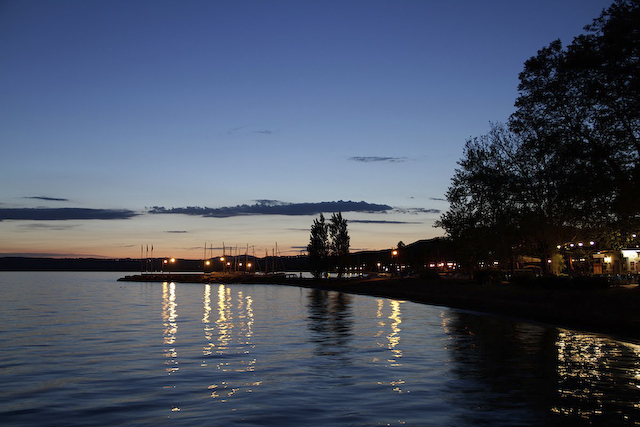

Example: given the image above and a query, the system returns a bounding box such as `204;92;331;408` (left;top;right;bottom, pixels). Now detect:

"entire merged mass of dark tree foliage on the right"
436;0;640;267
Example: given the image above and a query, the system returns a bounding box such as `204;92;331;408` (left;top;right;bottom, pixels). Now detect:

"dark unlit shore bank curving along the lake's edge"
119;274;640;343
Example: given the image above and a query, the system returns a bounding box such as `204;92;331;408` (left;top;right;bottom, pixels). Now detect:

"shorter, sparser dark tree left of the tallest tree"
436;124;528;267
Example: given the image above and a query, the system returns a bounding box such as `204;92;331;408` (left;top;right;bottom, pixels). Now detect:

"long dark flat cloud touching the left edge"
0;208;138;221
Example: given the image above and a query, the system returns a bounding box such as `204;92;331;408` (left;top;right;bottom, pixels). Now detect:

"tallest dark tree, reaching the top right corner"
510;0;640;247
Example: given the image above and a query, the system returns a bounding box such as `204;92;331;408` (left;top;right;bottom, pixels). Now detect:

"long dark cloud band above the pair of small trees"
149;200;393;218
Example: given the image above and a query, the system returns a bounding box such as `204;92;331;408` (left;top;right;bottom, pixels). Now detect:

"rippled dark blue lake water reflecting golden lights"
0;272;640;426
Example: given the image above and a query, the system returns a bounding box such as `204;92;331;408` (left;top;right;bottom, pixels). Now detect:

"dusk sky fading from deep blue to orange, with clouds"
0;0;611;259
